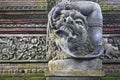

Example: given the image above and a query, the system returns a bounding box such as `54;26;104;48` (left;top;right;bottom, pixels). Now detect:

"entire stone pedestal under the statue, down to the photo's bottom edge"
46;59;104;80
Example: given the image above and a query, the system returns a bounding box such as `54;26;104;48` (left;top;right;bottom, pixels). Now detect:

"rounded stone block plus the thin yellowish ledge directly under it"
47;59;104;76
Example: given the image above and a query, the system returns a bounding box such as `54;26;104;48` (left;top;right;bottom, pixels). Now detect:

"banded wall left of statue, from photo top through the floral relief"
0;0;48;63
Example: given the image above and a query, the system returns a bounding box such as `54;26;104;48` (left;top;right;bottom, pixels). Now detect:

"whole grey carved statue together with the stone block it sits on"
47;0;104;76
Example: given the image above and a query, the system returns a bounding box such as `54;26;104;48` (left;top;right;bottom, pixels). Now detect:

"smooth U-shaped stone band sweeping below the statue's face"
58;38;104;59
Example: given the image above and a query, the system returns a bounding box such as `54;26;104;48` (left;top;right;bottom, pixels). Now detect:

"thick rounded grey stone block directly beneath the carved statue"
48;58;102;71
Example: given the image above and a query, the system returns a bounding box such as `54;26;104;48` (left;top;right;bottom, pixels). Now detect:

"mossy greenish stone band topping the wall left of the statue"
0;0;47;10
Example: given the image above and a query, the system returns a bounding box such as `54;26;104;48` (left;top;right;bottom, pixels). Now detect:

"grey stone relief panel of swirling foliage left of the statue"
0;36;46;61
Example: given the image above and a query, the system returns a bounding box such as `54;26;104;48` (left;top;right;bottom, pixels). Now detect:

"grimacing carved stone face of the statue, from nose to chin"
56;16;87;54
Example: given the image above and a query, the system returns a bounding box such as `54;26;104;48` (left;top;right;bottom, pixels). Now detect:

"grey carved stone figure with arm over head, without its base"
48;1;103;58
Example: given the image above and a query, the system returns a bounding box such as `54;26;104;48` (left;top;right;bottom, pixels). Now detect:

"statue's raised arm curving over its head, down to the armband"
53;1;103;27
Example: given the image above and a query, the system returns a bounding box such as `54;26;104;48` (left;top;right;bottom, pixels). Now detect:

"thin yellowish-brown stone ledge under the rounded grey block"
45;70;105;77
